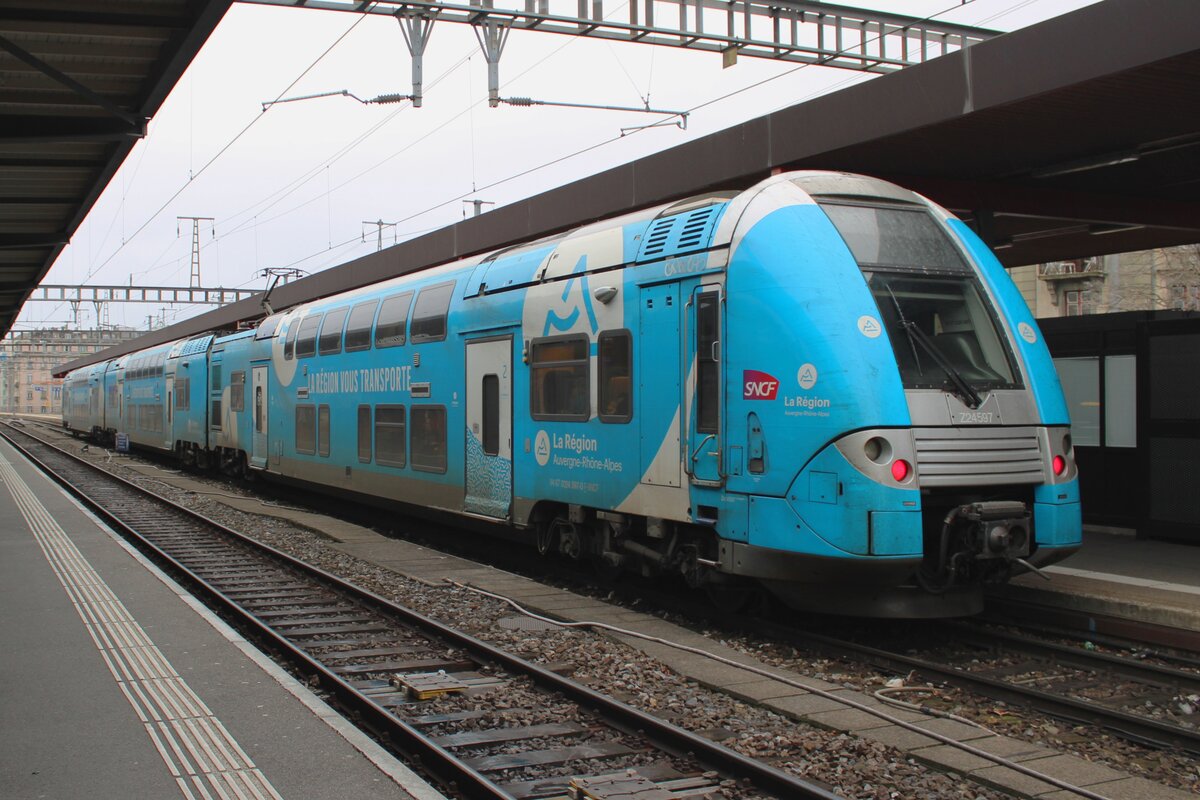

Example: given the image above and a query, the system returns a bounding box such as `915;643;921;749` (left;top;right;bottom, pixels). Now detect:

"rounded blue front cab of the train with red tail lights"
688;175;1081;616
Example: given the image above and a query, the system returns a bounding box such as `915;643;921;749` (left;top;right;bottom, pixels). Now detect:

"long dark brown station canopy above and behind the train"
7;0;1200;369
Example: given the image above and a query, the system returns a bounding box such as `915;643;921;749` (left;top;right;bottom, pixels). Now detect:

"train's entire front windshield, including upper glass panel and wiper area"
821;201;1016;395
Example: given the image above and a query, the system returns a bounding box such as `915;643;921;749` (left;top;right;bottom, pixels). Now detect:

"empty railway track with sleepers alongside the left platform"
0;426;838;800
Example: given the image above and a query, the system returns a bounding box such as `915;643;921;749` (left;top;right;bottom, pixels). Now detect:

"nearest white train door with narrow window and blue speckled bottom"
464;336;512;519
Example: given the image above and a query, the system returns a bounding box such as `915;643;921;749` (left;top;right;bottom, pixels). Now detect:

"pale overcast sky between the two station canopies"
16;0;1093;330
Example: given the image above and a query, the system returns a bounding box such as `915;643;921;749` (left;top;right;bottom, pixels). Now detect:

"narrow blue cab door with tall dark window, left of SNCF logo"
685;284;721;485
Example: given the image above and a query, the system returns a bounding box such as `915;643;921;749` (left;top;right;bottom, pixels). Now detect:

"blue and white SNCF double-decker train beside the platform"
64;172;1081;616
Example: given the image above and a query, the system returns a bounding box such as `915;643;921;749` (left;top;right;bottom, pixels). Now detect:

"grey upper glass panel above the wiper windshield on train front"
821;200;970;273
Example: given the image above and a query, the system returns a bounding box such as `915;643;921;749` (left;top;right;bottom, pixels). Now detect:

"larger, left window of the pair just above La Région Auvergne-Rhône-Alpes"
529;333;592;421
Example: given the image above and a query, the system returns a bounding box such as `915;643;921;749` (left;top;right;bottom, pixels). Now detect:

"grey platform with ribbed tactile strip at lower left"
0;441;442;800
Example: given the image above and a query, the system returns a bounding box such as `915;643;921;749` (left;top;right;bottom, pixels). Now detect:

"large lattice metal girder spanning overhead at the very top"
244;0;1000;71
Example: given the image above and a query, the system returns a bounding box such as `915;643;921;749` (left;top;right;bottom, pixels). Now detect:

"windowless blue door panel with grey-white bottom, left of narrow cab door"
634;283;682;486
